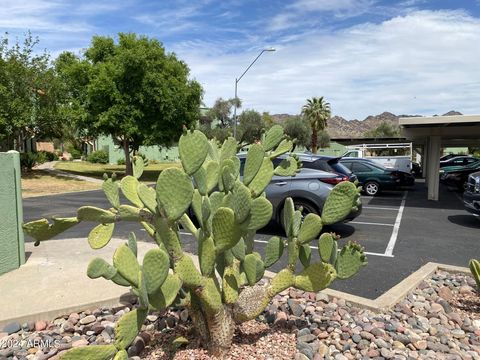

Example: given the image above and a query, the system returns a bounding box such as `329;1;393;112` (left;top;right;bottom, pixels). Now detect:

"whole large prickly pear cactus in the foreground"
24;125;366;360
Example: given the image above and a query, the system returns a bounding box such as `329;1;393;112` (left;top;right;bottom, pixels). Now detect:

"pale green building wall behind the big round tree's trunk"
97;136;178;164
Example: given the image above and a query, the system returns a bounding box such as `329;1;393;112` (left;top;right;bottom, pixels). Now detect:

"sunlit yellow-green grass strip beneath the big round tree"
55;161;180;181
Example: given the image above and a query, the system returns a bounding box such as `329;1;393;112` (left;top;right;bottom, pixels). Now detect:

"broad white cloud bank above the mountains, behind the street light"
175;11;480;118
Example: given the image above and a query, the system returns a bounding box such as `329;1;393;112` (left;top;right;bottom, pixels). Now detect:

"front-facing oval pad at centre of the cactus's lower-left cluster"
142;249;170;294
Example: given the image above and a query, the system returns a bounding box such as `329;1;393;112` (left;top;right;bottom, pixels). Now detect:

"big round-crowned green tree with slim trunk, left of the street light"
58;33;202;174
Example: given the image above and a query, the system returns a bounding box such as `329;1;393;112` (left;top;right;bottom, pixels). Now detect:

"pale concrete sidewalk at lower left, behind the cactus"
0;238;157;329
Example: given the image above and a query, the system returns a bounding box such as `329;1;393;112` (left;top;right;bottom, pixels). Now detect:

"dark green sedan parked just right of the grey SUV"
340;158;415;196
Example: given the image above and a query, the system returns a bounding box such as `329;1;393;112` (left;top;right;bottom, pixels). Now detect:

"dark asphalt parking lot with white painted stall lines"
24;180;480;299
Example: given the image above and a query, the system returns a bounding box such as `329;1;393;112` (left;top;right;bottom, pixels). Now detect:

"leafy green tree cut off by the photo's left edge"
0;33;62;150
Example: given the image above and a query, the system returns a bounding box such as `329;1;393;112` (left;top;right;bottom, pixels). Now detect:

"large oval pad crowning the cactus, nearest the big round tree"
178;130;209;175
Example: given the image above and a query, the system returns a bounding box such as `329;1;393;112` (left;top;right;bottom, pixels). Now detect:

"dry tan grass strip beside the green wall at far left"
22;170;101;198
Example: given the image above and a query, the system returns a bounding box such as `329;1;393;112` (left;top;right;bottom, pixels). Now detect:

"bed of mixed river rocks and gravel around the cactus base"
0;271;480;360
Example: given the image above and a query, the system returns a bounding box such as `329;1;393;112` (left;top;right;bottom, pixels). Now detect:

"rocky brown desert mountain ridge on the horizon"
272;110;462;138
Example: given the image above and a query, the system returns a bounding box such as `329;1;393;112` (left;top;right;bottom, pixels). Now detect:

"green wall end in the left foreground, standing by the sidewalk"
0;151;25;274
